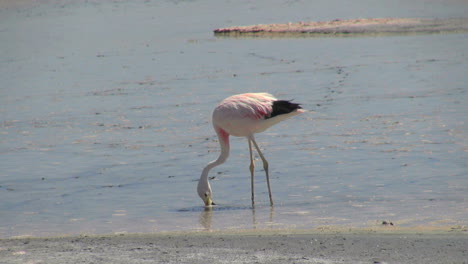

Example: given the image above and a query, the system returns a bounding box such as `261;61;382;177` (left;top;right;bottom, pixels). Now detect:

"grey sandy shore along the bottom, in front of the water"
0;228;468;263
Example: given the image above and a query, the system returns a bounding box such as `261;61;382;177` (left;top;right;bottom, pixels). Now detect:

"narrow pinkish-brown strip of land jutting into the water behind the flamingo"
213;18;468;36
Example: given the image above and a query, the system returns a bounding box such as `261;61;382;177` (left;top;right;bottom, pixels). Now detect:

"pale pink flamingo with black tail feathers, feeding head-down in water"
197;93;305;207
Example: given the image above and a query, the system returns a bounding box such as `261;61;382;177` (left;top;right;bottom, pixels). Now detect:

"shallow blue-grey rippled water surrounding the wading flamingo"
0;1;468;237
